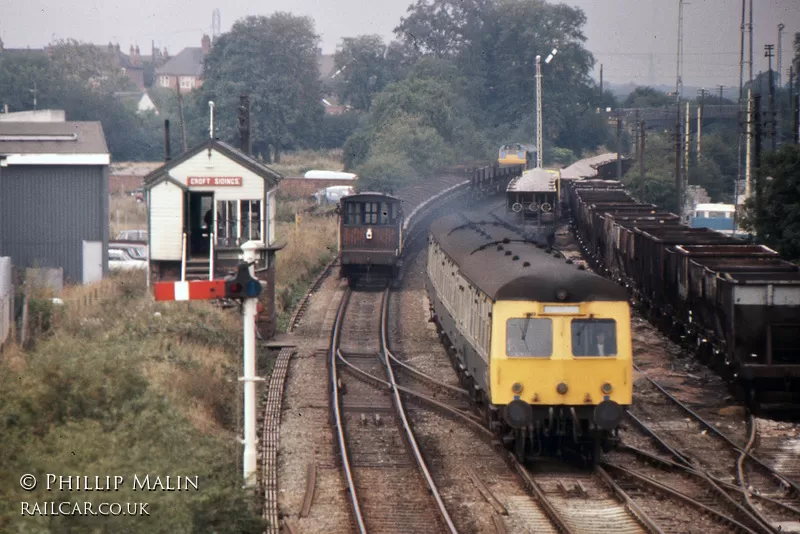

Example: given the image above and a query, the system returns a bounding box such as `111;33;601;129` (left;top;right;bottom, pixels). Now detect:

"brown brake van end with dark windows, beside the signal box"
338;193;403;280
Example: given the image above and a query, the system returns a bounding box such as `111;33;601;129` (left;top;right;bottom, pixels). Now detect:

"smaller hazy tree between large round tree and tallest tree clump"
334;35;387;111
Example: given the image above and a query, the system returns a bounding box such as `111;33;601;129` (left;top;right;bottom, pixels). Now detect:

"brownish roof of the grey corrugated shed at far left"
0;121;108;155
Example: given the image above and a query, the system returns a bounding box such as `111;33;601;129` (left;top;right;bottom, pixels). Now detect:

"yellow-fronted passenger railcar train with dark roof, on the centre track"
426;212;633;460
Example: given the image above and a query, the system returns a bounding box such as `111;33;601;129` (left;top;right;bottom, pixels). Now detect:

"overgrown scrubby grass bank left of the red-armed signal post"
0;273;263;533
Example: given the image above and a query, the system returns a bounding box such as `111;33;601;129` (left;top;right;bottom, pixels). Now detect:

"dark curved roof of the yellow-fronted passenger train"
430;211;628;302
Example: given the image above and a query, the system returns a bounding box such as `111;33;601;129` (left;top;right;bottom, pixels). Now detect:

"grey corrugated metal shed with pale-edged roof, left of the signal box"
0;122;110;283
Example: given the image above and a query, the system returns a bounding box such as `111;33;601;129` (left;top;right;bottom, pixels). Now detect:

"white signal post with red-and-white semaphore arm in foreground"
153;241;264;487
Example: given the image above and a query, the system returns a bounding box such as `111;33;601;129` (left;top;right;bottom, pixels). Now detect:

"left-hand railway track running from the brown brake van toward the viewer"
329;288;457;533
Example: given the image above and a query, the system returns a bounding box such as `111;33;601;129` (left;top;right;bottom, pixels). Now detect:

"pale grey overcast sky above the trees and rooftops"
0;0;800;88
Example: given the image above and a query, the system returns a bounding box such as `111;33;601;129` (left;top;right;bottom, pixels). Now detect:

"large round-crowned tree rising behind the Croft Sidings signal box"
202;13;324;162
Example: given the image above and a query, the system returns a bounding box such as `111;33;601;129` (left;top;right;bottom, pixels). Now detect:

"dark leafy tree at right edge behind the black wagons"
743;144;800;260
